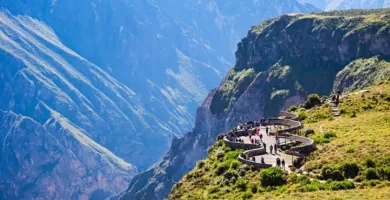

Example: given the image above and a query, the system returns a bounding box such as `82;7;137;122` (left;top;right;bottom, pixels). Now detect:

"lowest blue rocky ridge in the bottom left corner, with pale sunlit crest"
0;111;136;199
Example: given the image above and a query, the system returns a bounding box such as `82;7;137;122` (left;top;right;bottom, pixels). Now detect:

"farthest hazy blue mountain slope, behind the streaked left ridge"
0;0;316;170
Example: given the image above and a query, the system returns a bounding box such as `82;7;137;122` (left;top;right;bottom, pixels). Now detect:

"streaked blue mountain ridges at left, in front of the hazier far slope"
0;11;140;199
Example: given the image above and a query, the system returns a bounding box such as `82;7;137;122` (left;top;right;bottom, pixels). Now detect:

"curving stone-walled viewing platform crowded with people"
218;112;315;172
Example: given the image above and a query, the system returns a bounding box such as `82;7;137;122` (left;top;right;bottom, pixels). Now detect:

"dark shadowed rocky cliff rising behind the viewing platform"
120;10;390;199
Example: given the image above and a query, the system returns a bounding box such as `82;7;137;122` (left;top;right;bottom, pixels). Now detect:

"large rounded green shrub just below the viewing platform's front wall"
260;167;286;187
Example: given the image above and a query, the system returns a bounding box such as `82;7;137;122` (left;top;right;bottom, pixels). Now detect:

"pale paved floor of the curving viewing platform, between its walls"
240;126;293;173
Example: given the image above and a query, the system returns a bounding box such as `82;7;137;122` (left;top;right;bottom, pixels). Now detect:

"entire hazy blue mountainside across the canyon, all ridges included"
0;0;316;199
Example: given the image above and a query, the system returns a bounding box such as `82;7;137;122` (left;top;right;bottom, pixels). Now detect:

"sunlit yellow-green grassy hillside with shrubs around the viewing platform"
169;80;390;199
